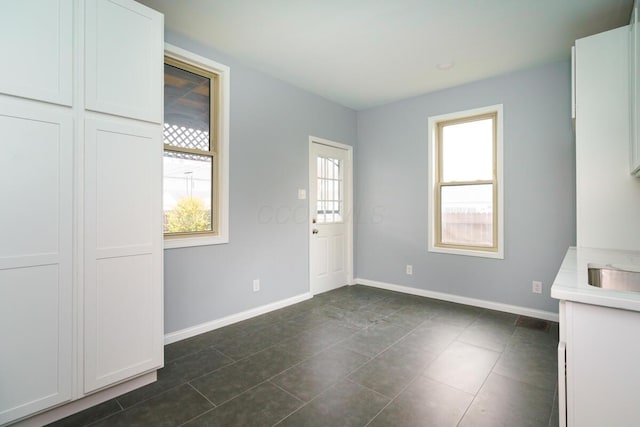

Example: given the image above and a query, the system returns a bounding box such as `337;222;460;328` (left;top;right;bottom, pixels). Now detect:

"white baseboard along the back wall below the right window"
354;278;559;322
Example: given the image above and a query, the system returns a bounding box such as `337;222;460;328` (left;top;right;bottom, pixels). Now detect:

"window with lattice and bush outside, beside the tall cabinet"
163;44;229;248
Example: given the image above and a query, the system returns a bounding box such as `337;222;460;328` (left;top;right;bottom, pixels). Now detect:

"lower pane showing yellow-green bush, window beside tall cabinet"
163;150;212;233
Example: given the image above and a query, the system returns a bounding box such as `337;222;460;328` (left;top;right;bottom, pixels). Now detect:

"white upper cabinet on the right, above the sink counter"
575;26;640;250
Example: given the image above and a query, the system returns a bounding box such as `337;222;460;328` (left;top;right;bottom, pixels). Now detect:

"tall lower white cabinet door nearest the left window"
84;118;163;392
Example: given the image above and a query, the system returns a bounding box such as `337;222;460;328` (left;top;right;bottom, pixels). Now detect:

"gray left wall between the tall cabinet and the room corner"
164;32;357;333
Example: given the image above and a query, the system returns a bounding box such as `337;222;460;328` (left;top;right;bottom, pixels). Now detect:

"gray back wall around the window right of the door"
355;61;576;311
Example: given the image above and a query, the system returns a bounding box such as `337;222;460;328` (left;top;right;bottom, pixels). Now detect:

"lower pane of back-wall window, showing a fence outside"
441;184;494;247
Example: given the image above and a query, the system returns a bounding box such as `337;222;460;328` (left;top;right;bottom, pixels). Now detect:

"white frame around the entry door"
307;135;353;295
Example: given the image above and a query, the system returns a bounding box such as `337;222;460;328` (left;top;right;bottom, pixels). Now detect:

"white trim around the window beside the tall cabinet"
164;43;231;249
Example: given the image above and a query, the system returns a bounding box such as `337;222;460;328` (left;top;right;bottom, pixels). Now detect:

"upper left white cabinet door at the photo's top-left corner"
0;0;73;105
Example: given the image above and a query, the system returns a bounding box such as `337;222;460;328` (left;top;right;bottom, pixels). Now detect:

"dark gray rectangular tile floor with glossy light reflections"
48;286;558;427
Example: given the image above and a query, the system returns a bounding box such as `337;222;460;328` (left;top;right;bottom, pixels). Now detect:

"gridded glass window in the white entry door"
316;157;344;224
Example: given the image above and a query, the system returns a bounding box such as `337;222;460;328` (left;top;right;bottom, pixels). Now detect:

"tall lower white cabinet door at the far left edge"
0;99;73;424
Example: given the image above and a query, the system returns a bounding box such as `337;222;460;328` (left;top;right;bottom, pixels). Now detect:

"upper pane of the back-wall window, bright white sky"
442;118;493;182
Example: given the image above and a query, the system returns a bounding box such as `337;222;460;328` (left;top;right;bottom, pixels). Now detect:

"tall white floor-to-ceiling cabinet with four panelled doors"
0;0;163;425
